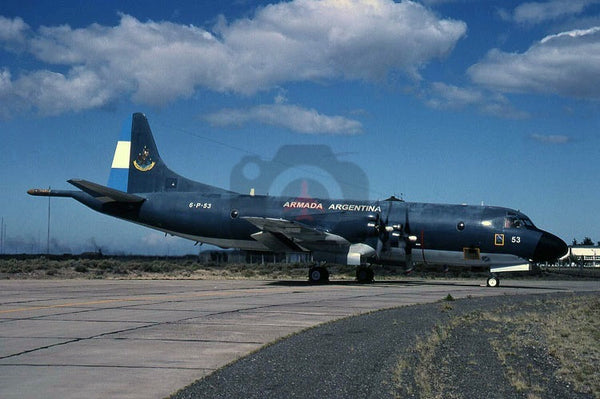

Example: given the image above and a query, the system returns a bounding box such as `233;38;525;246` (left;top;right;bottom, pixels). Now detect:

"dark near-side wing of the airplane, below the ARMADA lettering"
243;216;350;252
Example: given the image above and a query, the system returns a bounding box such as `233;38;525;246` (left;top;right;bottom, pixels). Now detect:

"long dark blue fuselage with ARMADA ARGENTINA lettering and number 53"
70;192;560;266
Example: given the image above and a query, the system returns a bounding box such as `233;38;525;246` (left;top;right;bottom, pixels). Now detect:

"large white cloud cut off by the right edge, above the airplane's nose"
467;28;600;99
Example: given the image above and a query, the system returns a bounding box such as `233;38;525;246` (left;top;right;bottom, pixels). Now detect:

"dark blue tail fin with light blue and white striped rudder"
108;113;229;193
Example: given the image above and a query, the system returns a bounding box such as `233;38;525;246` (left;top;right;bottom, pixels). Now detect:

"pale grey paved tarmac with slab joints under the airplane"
0;279;600;399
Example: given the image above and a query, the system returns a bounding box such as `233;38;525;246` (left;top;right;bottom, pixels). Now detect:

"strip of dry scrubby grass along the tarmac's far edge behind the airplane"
0;255;502;281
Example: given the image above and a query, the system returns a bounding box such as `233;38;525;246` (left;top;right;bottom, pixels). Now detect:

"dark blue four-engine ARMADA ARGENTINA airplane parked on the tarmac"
28;113;567;287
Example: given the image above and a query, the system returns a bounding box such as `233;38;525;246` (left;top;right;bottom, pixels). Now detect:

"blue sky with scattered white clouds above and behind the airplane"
0;0;600;254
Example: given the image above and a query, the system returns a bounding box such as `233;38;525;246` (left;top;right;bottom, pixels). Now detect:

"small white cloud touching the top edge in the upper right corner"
512;0;598;24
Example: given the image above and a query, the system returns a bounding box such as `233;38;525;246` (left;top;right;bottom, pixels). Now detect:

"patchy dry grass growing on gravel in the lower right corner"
394;296;600;399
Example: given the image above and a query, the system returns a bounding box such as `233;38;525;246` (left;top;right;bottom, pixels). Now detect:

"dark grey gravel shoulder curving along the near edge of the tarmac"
172;294;593;398
